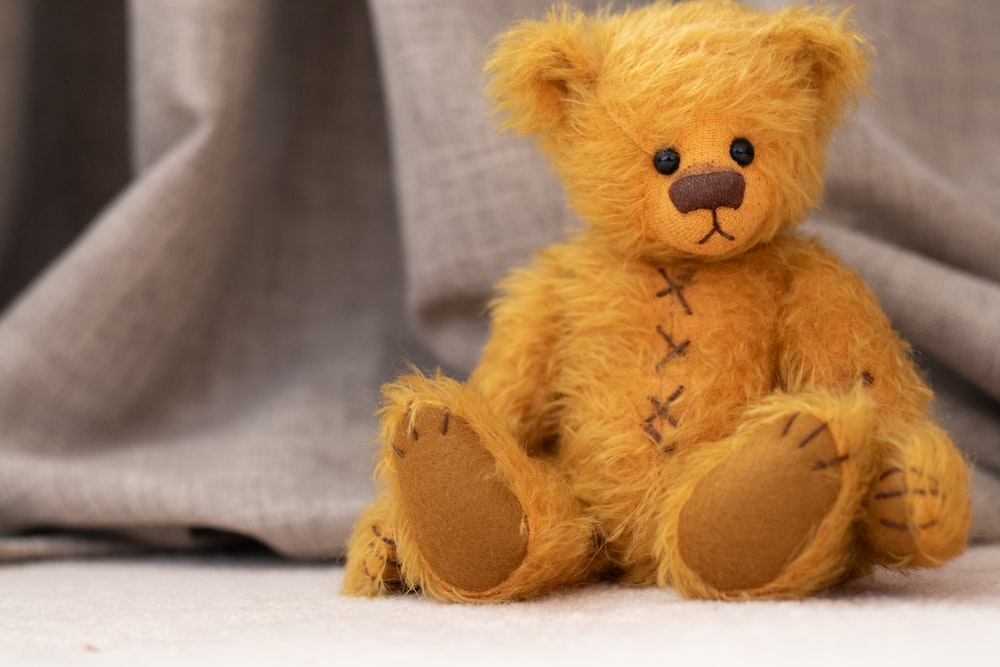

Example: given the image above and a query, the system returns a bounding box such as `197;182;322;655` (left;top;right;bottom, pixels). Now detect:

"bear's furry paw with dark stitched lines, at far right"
861;419;970;568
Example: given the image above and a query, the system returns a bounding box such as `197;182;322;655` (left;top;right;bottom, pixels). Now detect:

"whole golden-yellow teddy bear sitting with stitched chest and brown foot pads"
343;0;970;602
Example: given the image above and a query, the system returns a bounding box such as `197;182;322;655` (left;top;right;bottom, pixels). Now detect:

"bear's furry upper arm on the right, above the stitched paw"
780;241;931;418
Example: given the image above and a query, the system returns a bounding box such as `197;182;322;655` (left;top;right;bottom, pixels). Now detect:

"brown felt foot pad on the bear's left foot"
394;407;527;593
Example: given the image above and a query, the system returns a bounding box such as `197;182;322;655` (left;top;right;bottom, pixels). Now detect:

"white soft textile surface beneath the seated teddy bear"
0;545;1000;667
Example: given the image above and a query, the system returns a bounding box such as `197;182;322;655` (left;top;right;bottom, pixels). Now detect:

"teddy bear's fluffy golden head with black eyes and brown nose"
486;0;867;259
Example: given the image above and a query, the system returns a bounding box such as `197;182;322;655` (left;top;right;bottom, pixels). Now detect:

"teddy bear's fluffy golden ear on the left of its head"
485;6;602;135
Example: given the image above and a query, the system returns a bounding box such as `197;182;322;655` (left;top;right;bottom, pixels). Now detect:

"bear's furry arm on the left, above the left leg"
470;252;563;451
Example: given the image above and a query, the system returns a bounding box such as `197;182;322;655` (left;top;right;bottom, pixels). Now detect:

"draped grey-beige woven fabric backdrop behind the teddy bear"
0;0;1000;561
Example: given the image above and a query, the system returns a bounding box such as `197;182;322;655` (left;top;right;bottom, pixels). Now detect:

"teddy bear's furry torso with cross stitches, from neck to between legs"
548;239;800;568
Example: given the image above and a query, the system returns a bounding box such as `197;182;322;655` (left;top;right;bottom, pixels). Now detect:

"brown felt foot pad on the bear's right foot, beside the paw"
678;414;848;592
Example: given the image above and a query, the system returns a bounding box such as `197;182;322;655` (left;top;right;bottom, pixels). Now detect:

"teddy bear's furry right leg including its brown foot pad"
660;391;874;599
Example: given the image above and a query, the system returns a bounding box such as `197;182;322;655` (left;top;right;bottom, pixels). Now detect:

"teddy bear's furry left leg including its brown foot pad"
354;376;596;601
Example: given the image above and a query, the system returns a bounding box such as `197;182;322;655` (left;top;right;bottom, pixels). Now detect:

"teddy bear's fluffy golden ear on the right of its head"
771;8;873;126
